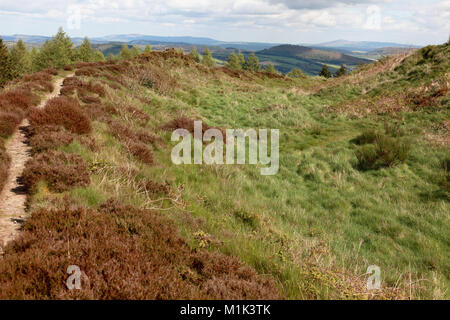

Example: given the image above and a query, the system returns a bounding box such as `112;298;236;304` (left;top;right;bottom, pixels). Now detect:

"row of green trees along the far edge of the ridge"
0;28;347;87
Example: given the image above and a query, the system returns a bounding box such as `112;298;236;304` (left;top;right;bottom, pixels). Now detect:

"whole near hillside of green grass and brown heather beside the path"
0;44;450;299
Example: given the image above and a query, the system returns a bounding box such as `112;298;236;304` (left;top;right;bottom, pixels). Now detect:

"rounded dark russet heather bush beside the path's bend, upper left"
29;97;92;134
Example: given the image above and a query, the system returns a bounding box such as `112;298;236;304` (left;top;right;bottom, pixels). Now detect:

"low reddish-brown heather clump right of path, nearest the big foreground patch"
23;151;90;192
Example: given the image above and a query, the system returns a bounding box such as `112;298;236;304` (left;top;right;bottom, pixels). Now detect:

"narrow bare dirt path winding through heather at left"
0;78;68;255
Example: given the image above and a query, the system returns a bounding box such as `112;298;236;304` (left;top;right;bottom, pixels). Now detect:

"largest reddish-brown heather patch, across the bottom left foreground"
0;201;279;299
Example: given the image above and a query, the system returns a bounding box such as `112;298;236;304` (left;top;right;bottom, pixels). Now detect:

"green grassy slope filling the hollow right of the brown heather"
4;43;450;298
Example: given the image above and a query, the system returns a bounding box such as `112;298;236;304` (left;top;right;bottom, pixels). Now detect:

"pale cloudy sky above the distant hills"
0;0;450;45
